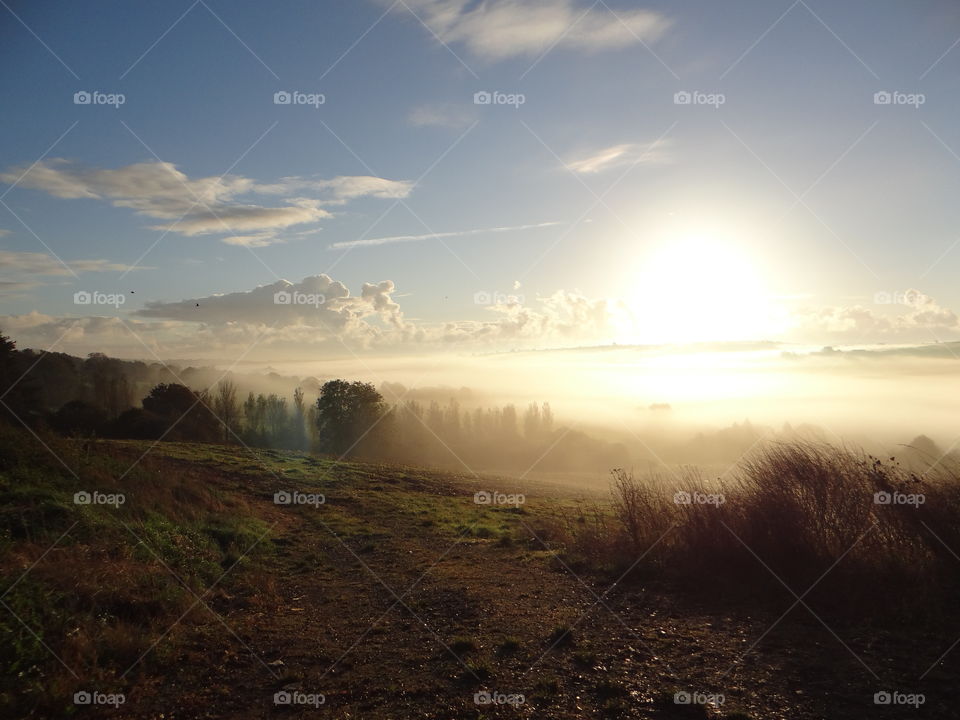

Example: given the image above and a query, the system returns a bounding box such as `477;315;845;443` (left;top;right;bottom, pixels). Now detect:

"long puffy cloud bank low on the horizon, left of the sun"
0;275;623;359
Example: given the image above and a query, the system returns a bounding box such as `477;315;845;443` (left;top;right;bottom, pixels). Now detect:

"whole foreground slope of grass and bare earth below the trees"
0;430;950;718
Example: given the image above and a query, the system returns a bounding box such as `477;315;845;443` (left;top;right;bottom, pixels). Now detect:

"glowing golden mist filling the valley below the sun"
242;342;960;456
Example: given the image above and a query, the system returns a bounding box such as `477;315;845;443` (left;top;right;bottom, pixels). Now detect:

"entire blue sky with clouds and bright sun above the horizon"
0;0;960;361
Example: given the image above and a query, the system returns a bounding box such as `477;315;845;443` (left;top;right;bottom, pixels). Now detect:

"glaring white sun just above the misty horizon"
628;233;774;343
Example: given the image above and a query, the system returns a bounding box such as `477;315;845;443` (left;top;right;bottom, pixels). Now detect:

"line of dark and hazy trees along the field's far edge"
0;335;626;470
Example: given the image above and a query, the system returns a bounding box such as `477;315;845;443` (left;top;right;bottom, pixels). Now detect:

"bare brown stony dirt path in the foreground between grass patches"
109;458;950;720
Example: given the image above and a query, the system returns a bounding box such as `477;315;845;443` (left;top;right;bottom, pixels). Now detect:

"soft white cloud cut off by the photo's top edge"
394;0;670;60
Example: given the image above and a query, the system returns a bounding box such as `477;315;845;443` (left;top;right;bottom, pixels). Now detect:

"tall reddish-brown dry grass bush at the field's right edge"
566;443;960;607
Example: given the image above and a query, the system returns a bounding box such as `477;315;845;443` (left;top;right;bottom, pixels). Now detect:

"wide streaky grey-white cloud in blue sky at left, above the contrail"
0;159;412;243
